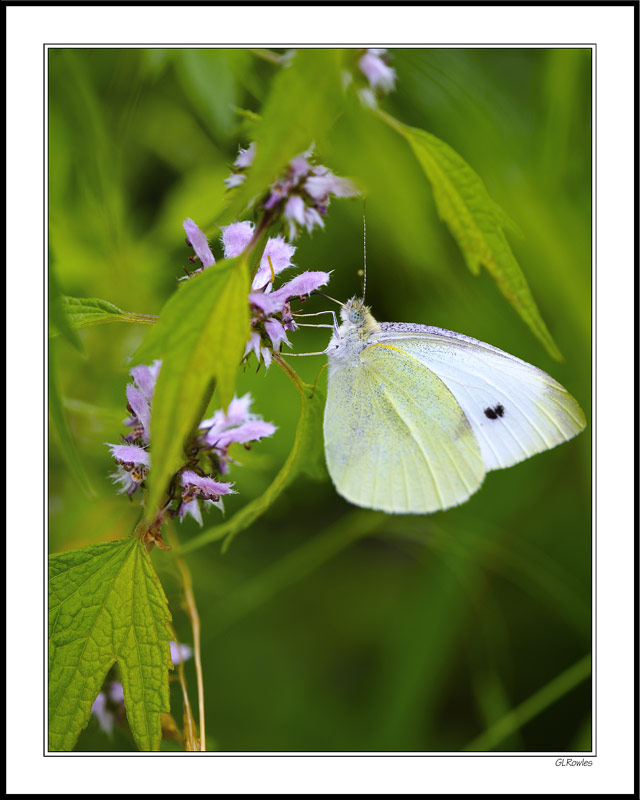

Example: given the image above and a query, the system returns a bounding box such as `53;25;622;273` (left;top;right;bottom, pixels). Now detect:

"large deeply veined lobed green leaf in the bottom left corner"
49;536;171;750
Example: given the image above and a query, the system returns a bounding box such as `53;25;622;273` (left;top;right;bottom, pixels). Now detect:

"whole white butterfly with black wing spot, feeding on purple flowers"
324;297;585;514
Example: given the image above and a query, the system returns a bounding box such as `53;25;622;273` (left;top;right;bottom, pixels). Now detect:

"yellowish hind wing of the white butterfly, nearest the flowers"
324;344;484;514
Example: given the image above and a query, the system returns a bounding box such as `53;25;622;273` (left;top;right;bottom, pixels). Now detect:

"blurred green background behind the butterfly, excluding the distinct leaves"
49;49;591;751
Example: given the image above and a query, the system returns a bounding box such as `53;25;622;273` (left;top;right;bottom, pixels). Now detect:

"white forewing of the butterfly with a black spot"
376;322;586;471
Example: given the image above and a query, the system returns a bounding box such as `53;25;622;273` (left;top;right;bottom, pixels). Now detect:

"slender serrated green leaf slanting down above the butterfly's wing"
376;110;562;360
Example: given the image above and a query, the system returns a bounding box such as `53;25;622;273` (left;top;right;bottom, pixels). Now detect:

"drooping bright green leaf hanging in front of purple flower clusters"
134;257;249;516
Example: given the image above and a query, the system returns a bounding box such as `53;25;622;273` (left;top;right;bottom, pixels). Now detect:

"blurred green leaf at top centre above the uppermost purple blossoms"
221;48;343;222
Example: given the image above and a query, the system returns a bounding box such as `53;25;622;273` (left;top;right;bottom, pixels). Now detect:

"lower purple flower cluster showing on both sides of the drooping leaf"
107;361;276;525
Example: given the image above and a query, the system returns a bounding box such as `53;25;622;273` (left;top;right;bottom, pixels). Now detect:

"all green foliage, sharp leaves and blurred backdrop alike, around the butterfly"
49;49;591;751
